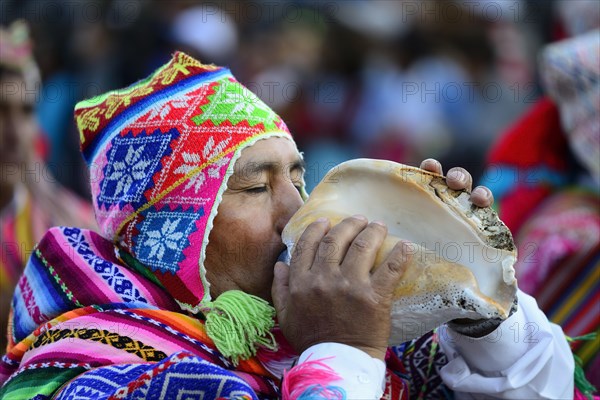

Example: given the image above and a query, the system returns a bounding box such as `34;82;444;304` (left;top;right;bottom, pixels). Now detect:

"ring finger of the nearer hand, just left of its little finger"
342;222;387;277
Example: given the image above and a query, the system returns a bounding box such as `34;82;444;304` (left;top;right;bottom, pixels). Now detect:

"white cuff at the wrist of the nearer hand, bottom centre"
298;343;385;400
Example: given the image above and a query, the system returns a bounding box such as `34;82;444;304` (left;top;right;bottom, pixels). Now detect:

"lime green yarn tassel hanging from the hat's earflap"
203;290;277;365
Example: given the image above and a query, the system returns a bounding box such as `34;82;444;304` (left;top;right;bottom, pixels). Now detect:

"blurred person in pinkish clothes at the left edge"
0;21;96;349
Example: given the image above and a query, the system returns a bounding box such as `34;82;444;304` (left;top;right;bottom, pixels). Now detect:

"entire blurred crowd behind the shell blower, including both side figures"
0;0;600;385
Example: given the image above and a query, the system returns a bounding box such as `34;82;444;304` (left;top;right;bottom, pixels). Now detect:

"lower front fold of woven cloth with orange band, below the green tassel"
0;304;278;399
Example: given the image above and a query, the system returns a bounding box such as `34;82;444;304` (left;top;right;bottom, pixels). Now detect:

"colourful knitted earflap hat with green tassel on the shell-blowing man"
75;52;304;360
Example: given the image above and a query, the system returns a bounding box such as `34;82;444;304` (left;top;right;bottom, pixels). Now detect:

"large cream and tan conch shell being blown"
282;159;517;344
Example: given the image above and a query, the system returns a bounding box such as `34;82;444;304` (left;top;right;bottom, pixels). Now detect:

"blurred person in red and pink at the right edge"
482;23;600;392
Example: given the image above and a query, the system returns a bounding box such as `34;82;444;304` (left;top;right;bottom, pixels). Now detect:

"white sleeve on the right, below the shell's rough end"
438;291;575;399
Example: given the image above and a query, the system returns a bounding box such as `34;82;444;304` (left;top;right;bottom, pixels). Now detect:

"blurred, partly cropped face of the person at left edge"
0;73;38;184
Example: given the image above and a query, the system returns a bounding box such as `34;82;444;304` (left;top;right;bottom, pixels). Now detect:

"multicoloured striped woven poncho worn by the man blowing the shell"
0;227;451;399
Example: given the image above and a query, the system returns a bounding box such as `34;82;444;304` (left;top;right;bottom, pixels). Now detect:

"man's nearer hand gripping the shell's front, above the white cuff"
272;216;406;360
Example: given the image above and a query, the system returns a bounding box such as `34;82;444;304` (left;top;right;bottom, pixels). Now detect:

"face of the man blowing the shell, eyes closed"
205;138;304;301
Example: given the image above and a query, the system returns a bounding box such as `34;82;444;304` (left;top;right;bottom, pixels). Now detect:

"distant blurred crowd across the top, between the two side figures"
0;0;600;196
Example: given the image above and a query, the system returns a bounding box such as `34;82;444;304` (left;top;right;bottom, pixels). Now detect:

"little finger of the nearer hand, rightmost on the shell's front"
371;241;414;295
